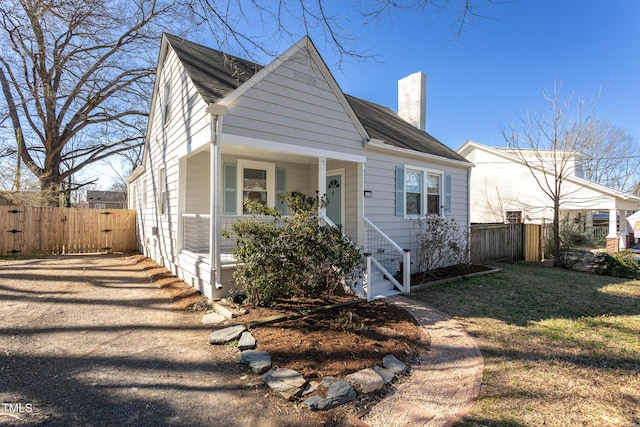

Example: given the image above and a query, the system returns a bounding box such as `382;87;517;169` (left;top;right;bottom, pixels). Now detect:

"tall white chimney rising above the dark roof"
398;72;427;130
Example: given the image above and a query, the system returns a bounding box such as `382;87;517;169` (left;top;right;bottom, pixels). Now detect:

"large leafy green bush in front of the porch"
227;194;362;305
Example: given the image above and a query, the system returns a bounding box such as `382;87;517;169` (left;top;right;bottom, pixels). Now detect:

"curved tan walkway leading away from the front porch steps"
363;296;484;427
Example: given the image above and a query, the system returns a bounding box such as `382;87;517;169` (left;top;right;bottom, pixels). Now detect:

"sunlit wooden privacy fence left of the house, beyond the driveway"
0;206;137;256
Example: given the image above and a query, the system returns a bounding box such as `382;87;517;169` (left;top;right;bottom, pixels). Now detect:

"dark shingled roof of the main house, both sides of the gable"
165;34;468;163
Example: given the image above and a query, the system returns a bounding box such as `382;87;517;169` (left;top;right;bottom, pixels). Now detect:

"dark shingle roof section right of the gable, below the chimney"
345;95;469;163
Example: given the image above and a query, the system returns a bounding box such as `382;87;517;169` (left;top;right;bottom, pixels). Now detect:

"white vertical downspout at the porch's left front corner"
207;104;227;289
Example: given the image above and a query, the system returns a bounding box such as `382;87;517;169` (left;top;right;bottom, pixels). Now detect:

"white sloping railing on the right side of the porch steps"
364;218;411;298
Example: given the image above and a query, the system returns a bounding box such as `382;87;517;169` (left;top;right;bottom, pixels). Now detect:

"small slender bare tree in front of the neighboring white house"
503;83;600;266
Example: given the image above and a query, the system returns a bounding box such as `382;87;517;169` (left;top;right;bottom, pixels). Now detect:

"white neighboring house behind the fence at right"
457;141;640;250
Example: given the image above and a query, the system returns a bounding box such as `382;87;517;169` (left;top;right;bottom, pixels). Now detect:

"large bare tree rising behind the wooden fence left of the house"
0;0;181;206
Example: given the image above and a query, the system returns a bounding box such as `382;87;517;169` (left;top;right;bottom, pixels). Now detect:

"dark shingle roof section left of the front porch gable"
164;33;262;103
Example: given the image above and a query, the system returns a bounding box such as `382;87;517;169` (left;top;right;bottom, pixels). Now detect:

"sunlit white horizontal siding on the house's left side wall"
133;44;210;288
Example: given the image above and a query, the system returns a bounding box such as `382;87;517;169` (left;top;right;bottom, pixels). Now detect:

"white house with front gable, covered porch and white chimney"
128;34;471;298
